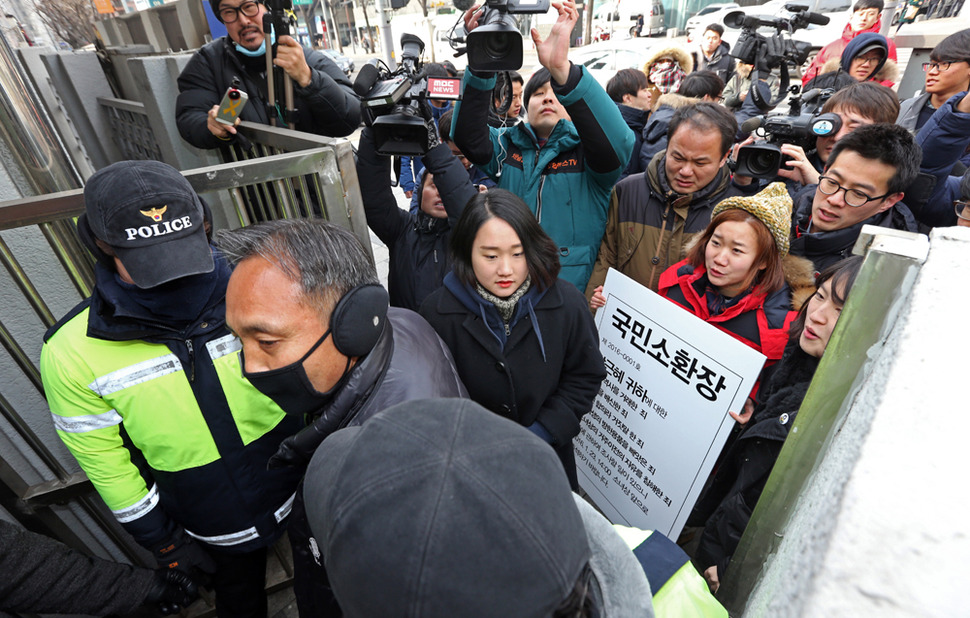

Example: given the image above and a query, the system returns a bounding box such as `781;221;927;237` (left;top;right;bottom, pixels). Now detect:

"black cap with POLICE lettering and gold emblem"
84;161;215;288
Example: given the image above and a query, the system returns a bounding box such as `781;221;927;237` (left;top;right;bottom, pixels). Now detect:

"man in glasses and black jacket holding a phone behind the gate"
175;0;360;148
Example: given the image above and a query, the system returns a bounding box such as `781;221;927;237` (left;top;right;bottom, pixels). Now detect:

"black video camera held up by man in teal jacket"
453;0;549;72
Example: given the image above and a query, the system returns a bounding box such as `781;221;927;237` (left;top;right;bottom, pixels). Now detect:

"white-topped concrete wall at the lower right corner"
744;228;970;617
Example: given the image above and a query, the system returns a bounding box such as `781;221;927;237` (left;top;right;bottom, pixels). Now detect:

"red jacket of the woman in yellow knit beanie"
659;260;797;367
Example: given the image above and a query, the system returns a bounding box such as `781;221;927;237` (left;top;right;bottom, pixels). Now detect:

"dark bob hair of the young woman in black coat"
450;189;560;290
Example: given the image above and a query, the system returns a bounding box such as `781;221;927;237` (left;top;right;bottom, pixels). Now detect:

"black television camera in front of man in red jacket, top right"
724;4;829;112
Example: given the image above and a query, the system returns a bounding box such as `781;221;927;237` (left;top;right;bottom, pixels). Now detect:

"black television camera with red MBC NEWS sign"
354;34;461;156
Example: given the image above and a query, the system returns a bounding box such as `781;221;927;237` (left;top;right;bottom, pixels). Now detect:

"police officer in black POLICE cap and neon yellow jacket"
41;161;301;617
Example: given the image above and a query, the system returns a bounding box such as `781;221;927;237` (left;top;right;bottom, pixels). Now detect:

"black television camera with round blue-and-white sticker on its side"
734;88;842;180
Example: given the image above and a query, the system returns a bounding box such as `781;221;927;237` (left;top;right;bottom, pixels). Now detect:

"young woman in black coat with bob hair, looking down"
421;189;606;489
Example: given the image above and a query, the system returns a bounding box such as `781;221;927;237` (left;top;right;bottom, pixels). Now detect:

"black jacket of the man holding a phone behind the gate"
175;37;360;148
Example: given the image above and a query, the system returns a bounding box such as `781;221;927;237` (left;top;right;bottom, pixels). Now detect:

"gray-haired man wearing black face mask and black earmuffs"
219;219;467;618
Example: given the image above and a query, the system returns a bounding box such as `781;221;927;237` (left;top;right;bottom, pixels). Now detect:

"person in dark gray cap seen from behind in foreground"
304;399;653;618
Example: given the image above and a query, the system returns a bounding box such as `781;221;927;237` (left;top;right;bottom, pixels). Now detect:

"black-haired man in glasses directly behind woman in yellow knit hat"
791;124;922;271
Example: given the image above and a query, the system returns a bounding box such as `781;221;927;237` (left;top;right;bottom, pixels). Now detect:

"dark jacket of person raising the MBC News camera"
357;128;475;311
